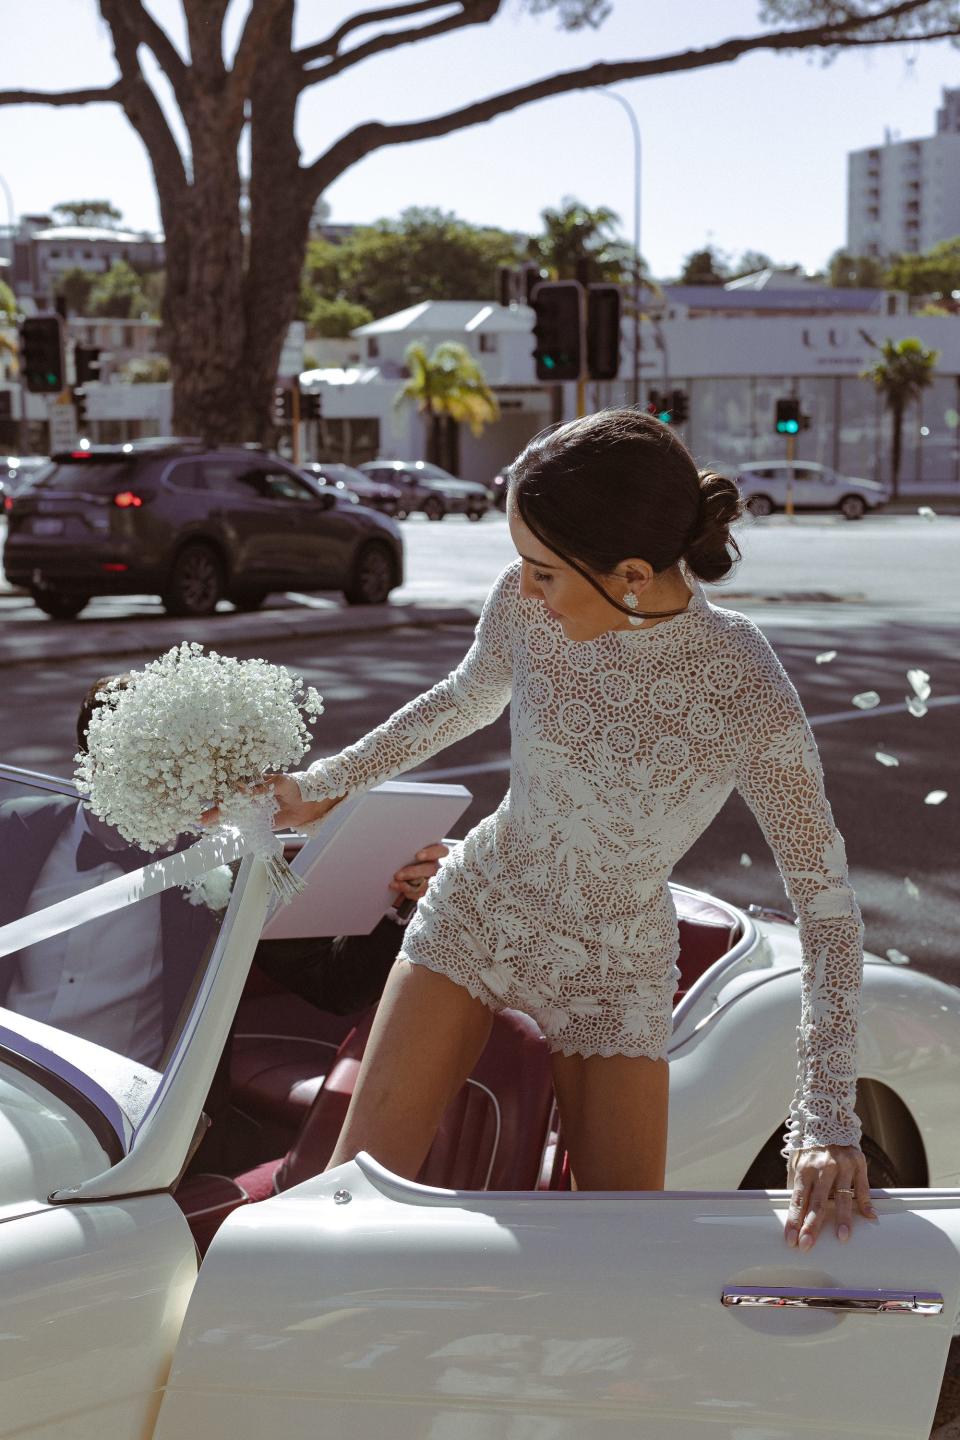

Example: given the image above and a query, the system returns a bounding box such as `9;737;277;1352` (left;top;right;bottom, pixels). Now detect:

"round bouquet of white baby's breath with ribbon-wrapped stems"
76;642;324;900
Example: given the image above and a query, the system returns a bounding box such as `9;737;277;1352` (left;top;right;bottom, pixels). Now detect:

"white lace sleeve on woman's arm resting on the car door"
737;636;864;1156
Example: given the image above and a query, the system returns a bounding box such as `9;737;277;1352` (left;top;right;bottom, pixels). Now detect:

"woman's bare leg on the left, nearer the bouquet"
327;960;494;1179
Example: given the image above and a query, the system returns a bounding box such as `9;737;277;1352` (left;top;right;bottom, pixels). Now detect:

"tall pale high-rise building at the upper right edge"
846;89;960;256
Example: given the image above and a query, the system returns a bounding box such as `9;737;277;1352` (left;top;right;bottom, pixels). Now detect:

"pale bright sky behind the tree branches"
0;0;960;278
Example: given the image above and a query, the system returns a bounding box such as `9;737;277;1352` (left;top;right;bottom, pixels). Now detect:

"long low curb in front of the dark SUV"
0;603;481;667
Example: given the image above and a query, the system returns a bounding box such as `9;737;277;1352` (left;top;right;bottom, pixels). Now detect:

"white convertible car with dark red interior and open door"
0;768;960;1440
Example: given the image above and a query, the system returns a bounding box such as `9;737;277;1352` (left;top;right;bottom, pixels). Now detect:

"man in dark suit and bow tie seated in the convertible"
0;677;446;1067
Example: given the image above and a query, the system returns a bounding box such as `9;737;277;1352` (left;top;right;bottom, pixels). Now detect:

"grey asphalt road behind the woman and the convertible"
0;516;960;984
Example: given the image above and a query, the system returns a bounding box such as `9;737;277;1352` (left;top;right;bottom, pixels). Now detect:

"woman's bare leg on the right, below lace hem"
553;1054;669;1189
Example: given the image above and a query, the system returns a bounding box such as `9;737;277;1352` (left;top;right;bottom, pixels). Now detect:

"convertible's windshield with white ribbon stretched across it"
0;766;239;1126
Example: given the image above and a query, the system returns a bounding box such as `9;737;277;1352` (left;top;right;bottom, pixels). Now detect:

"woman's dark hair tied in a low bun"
508;409;743;615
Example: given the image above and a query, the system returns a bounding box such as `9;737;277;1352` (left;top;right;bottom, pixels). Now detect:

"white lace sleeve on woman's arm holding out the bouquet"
294;567;517;801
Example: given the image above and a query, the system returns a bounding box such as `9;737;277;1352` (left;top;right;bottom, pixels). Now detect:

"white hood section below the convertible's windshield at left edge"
0;1060;111;1218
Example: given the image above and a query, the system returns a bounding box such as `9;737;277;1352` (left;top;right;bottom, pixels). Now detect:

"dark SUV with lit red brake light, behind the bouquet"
3;442;403;619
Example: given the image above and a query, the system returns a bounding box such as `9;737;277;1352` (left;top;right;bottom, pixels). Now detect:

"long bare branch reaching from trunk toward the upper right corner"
302;0;953;194
